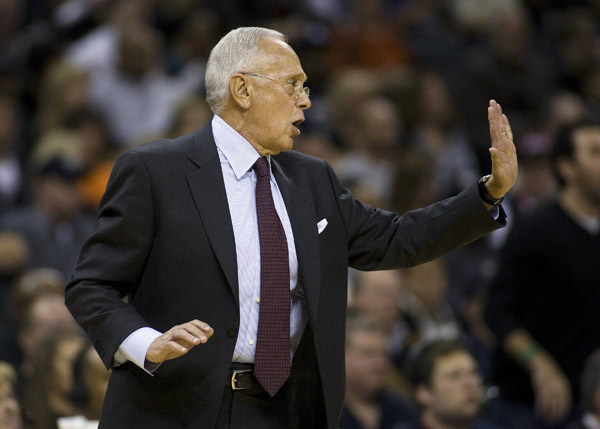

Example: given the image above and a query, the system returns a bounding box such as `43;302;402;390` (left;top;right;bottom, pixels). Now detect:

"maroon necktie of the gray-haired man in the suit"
253;158;291;396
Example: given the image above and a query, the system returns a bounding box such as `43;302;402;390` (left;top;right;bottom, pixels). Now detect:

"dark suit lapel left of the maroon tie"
187;123;239;305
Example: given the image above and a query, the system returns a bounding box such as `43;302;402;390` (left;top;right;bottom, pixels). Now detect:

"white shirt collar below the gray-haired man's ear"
211;115;270;180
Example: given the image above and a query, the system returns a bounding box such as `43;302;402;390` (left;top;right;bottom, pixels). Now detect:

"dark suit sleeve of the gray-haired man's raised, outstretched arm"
329;162;506;270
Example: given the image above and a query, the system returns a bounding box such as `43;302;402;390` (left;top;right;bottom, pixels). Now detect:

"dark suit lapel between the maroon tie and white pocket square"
271;157;321;323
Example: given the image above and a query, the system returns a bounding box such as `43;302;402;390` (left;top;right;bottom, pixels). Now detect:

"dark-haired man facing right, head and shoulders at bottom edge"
402;340;504;429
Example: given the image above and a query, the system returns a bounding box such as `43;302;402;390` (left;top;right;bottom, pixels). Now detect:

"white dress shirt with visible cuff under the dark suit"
115;115;307;368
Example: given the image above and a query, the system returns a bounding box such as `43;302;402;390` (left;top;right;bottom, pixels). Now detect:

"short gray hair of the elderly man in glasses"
205;27;287;114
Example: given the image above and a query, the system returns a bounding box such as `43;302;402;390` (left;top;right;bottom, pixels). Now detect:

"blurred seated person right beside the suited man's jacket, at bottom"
340;313;417;429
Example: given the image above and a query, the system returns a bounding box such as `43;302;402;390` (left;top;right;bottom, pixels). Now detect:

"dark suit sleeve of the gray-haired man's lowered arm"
65;152;154;368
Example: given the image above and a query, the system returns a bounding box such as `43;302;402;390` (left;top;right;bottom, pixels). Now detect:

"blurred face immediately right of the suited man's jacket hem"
346;329;389;399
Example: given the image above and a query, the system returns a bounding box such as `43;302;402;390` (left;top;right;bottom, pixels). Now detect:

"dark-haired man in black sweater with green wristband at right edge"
485;118;600;429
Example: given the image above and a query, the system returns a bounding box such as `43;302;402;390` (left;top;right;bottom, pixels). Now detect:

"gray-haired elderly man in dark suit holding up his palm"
66;28;517;429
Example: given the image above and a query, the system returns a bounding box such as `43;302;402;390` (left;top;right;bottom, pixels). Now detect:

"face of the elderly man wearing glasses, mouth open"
241;37;311;156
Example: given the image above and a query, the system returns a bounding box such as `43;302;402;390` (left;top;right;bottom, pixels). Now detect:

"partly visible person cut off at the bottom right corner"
567;349;600;429
